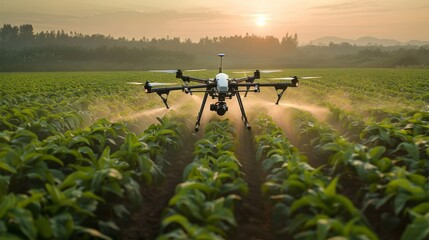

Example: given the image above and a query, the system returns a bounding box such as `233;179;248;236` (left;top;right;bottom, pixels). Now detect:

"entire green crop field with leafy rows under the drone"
0;68;429;240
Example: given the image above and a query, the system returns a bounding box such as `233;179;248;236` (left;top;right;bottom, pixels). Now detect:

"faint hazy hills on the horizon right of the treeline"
308;36;429;46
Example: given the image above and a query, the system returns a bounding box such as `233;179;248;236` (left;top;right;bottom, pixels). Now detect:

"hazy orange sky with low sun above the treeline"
0;0;429;43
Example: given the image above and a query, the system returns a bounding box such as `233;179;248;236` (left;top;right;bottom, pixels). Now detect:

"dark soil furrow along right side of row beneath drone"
229;128;274;240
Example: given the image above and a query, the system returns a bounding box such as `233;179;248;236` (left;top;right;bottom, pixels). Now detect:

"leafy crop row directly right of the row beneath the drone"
255;116;377;239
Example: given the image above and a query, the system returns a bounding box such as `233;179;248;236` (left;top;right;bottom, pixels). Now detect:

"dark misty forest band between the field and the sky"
0;24;429;72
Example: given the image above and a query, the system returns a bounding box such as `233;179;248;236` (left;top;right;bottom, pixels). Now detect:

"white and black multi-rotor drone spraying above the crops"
129;53;319;132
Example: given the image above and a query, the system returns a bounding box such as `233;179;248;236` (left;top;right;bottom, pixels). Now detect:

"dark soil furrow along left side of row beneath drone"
121;131;198;240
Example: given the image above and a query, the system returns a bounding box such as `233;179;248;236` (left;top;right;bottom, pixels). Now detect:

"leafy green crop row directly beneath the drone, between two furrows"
159;120;248;239
